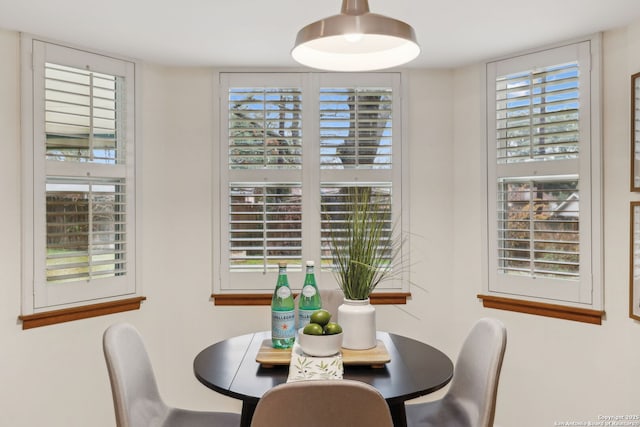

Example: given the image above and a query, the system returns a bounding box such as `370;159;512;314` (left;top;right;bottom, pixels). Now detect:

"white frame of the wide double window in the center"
212;70;409;298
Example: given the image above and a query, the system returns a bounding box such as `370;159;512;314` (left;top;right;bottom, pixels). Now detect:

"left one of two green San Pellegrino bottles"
271;262;296;348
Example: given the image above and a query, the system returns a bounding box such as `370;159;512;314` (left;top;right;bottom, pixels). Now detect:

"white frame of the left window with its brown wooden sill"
19;34;145;329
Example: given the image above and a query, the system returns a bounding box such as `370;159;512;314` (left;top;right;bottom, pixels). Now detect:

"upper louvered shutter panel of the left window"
45;63;125;164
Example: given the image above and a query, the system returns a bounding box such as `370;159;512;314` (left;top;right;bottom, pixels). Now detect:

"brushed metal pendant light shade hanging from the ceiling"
291;0;420;71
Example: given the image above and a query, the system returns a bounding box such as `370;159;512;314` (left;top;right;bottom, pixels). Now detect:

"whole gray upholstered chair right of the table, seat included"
406;318;507;427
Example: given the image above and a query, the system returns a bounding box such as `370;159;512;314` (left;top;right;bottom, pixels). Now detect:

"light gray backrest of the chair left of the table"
102;323;169;427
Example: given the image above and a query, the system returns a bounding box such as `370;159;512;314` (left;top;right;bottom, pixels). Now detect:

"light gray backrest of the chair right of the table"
445;318;507;427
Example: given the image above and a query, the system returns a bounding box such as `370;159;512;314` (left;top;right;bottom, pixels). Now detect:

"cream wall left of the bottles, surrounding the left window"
0;30;250;427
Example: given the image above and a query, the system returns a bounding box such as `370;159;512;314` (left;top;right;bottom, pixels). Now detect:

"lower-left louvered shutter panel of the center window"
229;183;302;271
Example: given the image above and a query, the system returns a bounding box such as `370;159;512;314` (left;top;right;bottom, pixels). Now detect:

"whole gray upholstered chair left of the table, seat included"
102;323;240;427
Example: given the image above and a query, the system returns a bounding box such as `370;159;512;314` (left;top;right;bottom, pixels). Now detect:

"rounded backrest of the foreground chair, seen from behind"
251;380;393;427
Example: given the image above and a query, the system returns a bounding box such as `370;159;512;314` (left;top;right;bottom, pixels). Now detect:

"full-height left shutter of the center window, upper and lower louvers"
221;78;303;283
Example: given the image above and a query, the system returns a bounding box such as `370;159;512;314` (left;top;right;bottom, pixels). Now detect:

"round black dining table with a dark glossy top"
193;331;453;427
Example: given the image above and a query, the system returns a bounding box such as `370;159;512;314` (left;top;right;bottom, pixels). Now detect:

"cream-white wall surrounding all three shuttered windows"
0;20;640;427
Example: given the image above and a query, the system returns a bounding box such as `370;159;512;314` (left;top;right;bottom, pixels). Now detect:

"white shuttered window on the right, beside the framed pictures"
487;39;602;320
